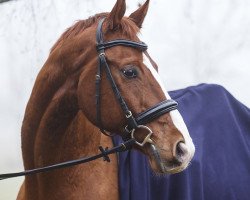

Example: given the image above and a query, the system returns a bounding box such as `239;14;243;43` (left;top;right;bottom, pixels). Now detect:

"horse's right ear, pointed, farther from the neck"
129;0;149;28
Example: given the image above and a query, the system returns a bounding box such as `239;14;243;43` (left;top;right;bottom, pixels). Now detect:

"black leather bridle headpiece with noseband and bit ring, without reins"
96;18;178;146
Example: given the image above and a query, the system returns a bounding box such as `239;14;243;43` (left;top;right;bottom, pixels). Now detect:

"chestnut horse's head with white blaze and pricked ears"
51;0;194;173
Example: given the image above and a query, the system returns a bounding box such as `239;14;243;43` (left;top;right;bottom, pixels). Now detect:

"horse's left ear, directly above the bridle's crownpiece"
107;0;126;30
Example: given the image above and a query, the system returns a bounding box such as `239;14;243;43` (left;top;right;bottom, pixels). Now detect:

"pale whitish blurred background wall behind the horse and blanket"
0;0;250;200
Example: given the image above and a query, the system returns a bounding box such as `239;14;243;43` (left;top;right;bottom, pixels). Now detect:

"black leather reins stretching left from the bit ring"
0;139;135;180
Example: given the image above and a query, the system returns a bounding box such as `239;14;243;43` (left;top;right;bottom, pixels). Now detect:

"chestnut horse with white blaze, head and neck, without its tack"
17;0;194;200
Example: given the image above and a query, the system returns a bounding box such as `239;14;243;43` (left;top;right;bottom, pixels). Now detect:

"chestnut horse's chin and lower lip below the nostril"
148;145;189;175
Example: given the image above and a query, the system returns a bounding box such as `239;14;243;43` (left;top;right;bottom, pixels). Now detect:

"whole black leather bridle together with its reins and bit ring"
0;18;178;180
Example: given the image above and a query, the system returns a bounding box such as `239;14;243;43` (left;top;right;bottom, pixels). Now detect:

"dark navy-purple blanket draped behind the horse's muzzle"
114;84;250;200
